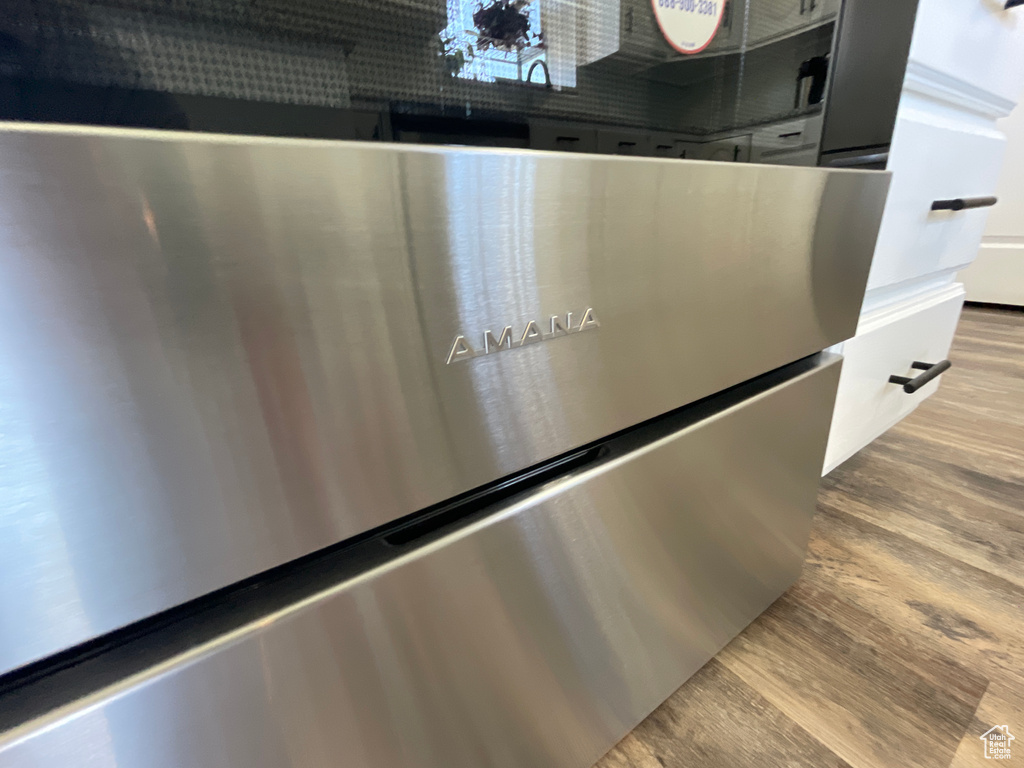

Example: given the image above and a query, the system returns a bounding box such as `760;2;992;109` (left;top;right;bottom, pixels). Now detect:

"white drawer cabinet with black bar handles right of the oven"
824;0;1024;472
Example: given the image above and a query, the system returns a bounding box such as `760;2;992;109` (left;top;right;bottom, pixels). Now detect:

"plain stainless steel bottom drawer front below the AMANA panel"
0;355;840;768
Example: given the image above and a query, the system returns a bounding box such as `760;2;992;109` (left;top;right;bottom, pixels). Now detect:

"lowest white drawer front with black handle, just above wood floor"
824;284;964;473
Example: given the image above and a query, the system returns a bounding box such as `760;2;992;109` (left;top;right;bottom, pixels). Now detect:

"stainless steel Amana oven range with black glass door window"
0;0;912;768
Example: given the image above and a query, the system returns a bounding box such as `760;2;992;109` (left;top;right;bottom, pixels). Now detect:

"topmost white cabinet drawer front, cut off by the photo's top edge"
907;0;1024;113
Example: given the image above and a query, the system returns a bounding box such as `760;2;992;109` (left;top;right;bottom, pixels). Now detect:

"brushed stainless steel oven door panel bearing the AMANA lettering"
0;124;889;673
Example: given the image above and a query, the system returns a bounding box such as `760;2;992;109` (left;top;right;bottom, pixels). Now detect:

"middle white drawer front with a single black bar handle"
867;111;1007;290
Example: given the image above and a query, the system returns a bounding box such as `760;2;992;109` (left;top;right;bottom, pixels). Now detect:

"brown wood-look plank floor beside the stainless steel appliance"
598;308;1024;768
